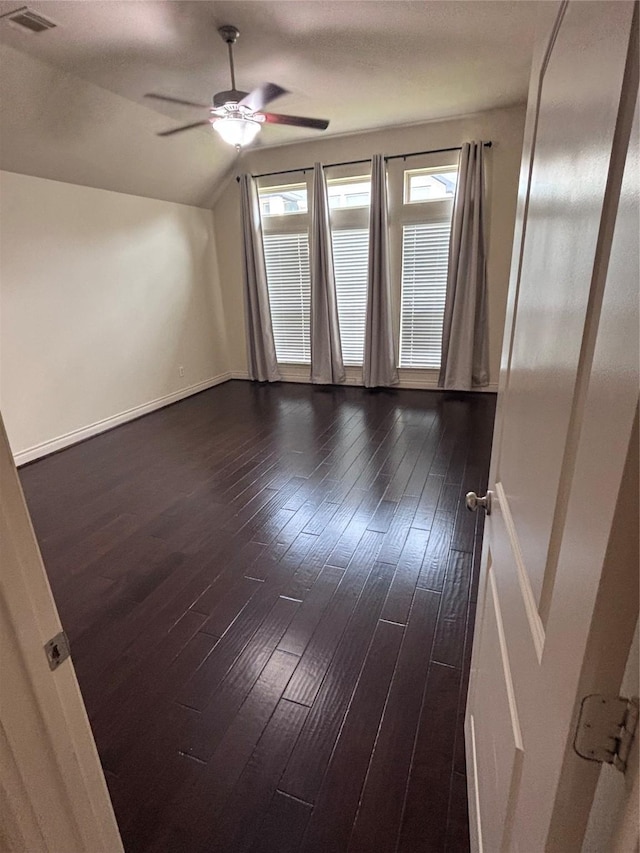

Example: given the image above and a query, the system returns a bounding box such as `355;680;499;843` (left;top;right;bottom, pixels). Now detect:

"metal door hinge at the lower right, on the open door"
573;693;638;773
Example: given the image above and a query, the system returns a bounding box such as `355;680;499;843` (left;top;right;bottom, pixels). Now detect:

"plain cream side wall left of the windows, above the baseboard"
0;172;228;462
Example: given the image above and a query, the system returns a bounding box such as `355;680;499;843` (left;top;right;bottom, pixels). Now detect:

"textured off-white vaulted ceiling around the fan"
0;0;537;207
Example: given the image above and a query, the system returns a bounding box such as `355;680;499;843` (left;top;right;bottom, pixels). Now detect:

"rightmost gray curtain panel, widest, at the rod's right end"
438;141;489;391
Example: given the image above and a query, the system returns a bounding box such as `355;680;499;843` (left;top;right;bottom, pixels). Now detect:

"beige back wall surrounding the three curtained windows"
214;106;525;390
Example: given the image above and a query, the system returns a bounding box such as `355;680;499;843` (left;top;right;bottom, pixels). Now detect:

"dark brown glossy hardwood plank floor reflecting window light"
20;381;495;853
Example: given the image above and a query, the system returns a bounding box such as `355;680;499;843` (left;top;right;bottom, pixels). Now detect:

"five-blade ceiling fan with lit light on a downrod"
145;26;329;150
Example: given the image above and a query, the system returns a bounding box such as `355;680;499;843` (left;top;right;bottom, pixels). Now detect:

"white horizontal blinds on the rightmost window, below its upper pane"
400;220;451;368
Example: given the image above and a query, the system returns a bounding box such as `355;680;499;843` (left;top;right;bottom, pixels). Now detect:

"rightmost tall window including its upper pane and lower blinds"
400;166;458;370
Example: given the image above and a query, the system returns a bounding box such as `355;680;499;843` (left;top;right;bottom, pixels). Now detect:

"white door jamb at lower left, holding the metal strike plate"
0;410;122;853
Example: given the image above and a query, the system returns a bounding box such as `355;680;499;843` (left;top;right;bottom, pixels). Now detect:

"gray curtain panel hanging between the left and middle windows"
309;163;345;385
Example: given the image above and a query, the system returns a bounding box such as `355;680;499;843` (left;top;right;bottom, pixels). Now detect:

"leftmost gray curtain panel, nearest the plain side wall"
240;175;281;382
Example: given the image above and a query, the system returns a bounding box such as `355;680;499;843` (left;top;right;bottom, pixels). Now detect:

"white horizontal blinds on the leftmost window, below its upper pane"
263;231;311;364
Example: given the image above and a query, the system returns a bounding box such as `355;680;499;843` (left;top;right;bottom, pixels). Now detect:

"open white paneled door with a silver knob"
466;0;638;853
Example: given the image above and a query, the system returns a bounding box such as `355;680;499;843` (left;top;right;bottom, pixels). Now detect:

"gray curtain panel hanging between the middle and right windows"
362;154;398;388
